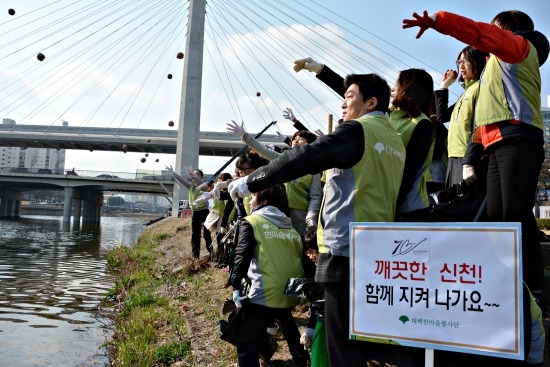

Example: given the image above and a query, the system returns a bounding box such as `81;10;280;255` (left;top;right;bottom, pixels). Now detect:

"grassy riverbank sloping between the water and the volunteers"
107;217;307;367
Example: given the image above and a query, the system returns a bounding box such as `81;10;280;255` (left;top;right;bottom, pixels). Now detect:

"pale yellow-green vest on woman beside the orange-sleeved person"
447;80;479;158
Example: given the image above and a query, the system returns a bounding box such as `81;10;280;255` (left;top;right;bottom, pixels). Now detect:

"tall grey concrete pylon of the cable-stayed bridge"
172;0;206;217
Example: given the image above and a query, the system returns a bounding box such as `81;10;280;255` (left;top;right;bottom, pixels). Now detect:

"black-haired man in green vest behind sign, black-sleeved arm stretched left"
229;74;418;366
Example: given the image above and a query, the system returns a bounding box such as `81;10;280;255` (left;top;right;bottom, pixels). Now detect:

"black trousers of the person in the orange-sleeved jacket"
487;139;544;291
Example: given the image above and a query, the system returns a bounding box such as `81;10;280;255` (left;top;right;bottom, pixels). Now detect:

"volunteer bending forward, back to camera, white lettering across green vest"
230;186;309;367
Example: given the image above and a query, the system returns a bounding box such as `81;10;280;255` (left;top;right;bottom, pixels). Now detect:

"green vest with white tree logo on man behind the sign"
317;112;405;256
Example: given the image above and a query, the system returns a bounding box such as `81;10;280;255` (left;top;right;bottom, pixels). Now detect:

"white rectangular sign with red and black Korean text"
350;223;524;359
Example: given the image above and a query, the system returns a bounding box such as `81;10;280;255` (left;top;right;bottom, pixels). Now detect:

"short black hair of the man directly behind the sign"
344;74;391;112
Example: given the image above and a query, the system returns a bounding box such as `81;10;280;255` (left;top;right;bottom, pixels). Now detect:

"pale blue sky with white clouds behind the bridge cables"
0;0;550;173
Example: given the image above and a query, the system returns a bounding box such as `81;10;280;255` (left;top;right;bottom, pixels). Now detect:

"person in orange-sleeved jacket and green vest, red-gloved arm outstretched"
403;10;550;365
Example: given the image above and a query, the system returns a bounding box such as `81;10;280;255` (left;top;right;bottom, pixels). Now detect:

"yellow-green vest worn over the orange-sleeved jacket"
475;44;543;129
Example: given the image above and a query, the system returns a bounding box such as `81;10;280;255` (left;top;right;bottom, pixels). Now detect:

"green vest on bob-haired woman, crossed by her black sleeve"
390;110;435;213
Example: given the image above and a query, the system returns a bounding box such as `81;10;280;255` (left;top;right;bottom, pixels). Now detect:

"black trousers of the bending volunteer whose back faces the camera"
236;303;309;367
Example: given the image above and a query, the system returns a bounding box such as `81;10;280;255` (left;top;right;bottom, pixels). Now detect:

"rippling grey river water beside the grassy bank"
0;216;147;367
